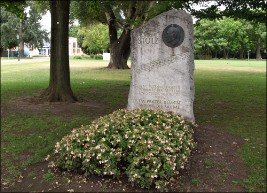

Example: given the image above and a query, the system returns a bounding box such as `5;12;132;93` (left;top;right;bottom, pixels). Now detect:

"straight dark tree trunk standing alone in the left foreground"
43;0;77;102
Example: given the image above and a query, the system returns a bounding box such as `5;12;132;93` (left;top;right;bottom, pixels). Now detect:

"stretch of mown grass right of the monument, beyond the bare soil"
195;60;266;191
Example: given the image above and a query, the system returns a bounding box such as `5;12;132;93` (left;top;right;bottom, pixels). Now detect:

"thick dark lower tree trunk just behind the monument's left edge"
108;29;131;69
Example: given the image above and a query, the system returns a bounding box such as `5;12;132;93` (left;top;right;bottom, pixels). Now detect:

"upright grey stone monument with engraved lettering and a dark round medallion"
127;9;195;122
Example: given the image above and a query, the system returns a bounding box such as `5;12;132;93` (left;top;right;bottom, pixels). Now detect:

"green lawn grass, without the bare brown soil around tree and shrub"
1;59;266;191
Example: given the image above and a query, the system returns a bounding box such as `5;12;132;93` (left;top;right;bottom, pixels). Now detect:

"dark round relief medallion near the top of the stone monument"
162;24;184;48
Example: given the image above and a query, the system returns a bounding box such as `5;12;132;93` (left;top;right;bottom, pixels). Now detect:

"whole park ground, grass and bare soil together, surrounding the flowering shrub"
1;60;266;192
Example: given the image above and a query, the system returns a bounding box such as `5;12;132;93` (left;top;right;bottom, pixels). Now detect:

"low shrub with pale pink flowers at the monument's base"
47;109;197;190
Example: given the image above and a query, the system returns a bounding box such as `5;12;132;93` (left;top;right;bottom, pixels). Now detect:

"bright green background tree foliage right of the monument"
194;17;266;59
